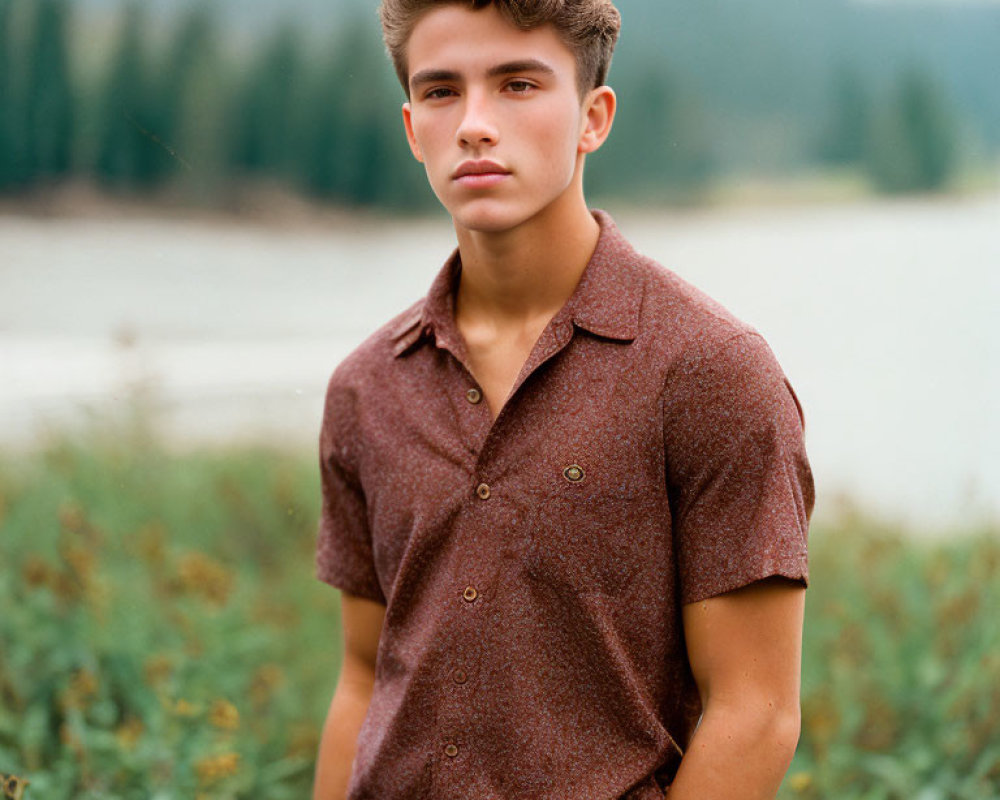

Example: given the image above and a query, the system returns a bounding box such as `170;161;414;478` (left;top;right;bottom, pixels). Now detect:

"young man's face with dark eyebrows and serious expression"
403;5;596;232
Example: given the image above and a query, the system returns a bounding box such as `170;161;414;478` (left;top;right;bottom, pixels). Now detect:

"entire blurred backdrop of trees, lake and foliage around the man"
0;0;1000;800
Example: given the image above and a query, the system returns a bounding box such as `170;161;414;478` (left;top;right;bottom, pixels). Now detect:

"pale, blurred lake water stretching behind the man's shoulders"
0;196;1000;531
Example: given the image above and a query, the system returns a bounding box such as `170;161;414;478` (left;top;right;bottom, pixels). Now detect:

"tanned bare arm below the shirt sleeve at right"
667;578;805;800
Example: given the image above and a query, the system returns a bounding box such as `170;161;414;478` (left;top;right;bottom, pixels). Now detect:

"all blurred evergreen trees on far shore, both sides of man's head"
0;0;958;207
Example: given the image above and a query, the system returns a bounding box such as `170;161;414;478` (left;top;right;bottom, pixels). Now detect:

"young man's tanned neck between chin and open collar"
455;193;600;328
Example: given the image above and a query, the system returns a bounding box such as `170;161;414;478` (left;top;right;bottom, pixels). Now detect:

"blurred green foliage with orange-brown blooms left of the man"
0;433;337;800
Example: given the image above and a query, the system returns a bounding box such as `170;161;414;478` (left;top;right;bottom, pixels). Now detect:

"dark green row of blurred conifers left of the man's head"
0;0;438;206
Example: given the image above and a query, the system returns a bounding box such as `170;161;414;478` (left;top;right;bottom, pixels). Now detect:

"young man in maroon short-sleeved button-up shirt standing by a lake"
314;0;813;800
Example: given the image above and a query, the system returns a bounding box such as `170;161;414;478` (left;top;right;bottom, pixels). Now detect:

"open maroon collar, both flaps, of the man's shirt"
392;210;644;356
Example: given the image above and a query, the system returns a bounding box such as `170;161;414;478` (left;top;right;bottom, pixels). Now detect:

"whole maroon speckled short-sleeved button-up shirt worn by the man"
317;211;813;800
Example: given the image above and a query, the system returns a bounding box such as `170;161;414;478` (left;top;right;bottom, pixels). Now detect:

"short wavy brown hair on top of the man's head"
379;0;621;96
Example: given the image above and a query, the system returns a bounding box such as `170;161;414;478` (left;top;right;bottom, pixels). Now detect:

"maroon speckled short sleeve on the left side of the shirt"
316;374;386;605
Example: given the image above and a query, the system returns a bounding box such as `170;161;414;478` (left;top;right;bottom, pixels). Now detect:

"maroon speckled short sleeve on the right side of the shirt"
663;332;814;604
